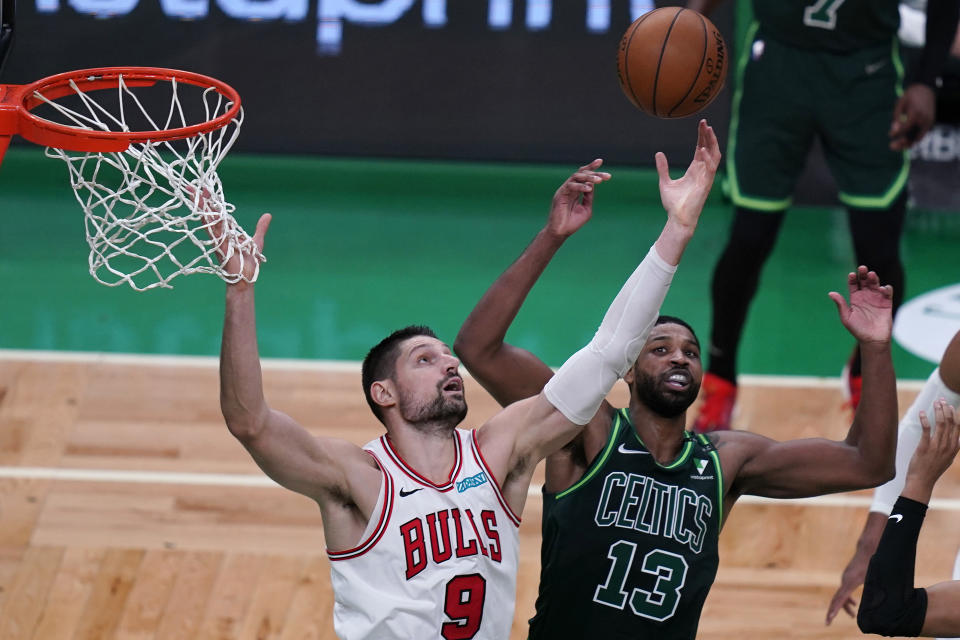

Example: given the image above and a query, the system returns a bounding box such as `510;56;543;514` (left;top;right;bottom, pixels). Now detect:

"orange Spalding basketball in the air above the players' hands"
617;7;727;118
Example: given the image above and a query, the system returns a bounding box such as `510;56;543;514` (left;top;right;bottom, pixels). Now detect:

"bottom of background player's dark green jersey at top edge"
753;0;900;52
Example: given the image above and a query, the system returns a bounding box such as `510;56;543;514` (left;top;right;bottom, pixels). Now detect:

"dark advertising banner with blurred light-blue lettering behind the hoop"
2;0;733;166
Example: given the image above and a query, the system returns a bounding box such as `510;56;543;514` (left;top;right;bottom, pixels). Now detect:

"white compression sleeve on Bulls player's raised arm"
543;247;677;424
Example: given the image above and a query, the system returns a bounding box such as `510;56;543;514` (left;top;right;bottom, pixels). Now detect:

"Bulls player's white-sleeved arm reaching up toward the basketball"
478;121;720;508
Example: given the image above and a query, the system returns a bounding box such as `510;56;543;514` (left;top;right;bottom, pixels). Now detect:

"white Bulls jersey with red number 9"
327;429;520;640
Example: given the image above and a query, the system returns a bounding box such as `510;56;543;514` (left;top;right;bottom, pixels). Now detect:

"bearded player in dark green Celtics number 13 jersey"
454;151;897;640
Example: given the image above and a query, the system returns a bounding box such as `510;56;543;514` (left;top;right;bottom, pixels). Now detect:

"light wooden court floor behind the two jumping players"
0;352;960;640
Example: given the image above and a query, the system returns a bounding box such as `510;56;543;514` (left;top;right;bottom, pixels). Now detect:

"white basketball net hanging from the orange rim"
35;76;265;291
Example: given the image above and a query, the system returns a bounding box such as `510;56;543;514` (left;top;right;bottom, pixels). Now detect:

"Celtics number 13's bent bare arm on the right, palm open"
728;266;898;499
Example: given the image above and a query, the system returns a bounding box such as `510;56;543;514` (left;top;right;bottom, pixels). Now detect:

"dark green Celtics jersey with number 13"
529;409;723;640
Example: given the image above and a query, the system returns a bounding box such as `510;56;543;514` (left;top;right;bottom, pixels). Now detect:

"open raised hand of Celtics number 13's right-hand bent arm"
829;265;893;342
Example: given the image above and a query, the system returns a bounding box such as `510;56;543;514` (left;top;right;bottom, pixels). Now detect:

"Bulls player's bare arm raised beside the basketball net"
220;214;380;528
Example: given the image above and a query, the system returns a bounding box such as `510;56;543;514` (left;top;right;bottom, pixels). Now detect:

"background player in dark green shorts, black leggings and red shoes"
687;0;957;432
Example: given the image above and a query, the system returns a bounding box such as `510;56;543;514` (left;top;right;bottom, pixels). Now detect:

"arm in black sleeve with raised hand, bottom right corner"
857;400;960;637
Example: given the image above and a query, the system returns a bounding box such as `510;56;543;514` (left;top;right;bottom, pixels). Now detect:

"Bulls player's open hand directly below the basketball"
656;120;720;227
